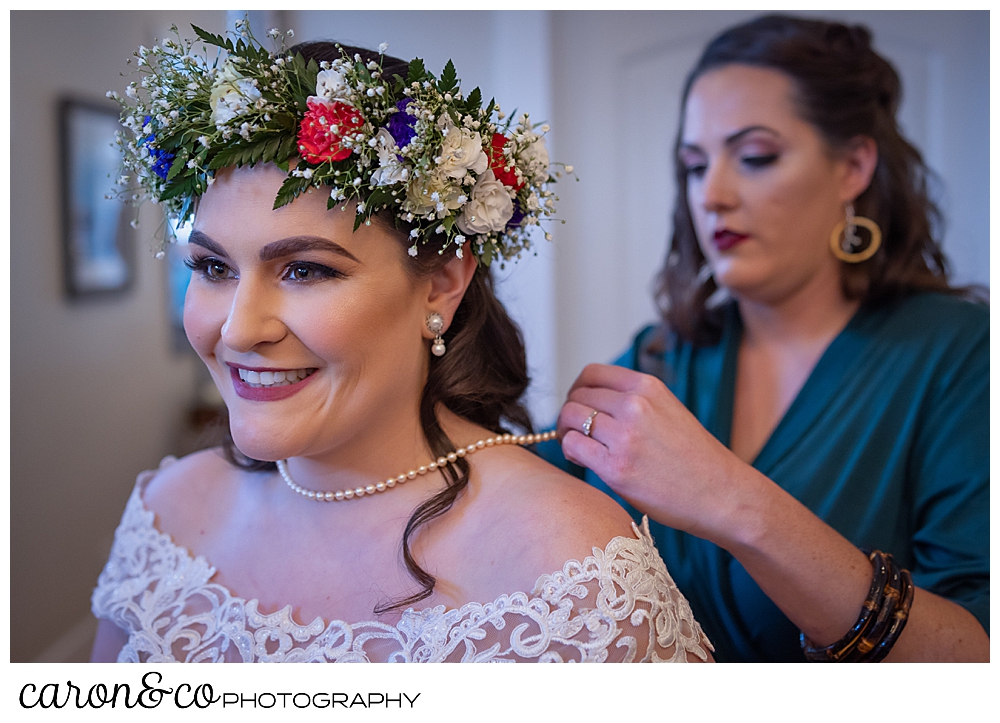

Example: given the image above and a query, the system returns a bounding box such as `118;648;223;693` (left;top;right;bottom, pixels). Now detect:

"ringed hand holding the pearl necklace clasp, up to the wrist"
558;364;757;542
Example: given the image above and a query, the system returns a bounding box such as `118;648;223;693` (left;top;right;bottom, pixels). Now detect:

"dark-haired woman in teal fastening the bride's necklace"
544;16;990;661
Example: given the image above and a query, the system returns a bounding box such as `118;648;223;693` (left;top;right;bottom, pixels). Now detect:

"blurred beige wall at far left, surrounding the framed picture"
10;12;225;661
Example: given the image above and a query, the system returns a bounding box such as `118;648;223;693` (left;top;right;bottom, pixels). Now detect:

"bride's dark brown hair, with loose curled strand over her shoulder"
216;42;533;615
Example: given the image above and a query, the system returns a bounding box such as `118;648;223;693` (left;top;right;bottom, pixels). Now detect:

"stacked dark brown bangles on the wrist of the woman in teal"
799;550;913;663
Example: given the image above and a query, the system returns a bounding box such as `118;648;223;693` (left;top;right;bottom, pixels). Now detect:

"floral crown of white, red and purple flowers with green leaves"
108;20;572;265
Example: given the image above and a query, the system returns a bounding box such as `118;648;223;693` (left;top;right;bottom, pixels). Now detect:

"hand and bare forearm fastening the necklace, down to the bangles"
558;364;871;645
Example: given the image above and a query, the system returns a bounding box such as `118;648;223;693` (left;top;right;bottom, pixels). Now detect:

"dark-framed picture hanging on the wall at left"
59;98;135;297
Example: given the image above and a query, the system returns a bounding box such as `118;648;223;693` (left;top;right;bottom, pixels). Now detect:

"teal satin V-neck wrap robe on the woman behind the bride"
539;294;990;661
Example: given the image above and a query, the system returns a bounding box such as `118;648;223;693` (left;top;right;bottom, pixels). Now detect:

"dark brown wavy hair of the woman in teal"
655;15;975;345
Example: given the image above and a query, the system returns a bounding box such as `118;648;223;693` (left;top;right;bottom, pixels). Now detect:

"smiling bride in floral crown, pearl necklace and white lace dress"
93;28;712;662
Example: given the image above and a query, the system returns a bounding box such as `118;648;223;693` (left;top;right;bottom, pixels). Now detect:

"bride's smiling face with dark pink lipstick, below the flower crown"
184;166;431;460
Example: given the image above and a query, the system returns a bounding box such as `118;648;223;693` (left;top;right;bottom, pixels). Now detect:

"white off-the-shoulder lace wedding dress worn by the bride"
91;472;713;663
